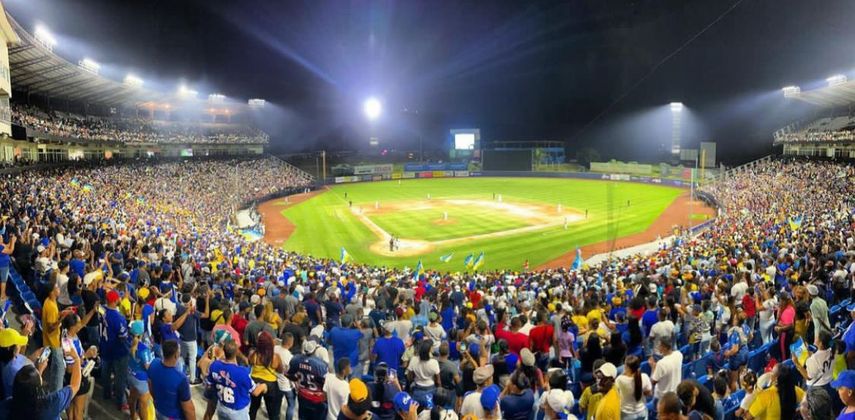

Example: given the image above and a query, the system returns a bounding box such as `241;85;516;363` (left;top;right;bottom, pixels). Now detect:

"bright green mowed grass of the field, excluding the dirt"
282;178;683;272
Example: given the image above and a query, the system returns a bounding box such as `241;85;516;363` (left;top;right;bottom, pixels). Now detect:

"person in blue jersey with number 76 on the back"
208;340;267;419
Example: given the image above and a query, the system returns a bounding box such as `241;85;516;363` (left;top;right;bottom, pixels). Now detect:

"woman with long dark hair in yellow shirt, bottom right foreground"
744;364;805;420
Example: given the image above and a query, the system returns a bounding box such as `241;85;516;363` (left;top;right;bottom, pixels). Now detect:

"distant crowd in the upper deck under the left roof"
12;105;270;144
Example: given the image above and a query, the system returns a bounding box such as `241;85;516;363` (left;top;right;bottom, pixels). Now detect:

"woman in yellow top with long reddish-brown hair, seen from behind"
249;331;285;419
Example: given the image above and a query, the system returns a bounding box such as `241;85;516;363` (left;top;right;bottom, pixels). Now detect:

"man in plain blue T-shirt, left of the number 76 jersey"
148;340;196;420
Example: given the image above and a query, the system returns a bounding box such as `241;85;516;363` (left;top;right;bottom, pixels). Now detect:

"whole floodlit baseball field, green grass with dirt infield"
259;178;702;271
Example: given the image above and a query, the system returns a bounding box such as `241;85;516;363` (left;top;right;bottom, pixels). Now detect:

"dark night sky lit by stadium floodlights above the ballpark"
4;0;855;162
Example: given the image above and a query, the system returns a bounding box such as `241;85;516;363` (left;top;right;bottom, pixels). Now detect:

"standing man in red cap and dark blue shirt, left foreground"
100;290;130;411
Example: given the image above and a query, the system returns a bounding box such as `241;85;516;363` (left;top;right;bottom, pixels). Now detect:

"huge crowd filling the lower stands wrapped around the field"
0;159;855;420
